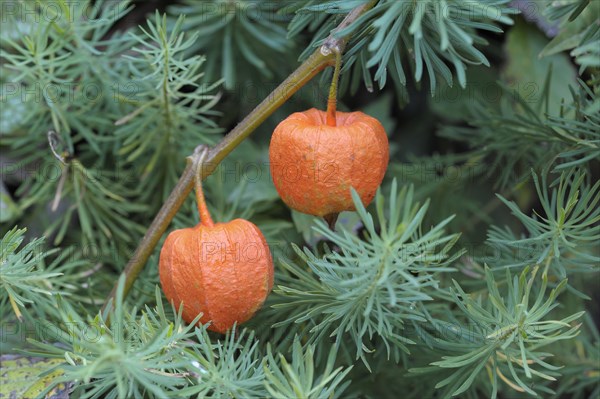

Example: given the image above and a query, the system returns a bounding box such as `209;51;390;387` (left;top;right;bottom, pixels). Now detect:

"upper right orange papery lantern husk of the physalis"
269;108;389;216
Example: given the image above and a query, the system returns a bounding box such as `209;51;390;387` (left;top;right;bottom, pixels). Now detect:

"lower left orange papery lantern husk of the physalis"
159;219;273;333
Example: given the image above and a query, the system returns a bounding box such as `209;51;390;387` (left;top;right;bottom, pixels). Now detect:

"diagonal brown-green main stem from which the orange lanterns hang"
102;0;376;314
